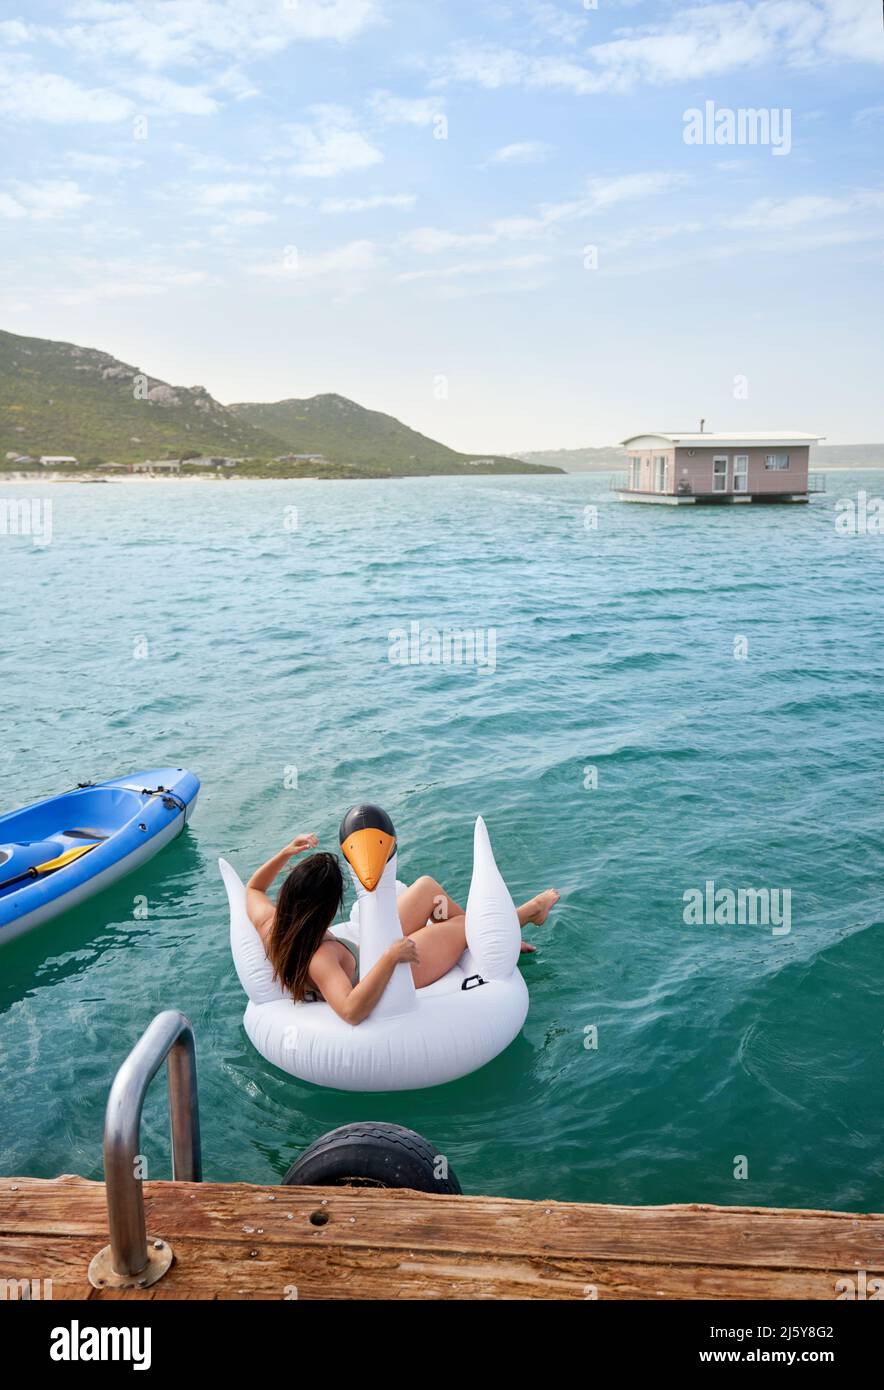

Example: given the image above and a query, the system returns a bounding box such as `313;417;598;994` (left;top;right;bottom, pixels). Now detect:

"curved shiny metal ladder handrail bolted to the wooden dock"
89;1009;203;1289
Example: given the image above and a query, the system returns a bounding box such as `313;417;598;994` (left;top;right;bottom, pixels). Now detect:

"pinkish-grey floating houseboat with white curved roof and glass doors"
612;420;826;506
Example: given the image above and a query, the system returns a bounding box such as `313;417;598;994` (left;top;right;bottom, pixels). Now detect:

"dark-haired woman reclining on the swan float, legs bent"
246;834;559;1024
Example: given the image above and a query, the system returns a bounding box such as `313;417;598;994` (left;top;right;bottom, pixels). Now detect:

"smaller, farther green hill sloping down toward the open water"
229;395;562;475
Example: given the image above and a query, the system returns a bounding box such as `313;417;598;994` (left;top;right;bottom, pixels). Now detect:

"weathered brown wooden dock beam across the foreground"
0;1177;884;1300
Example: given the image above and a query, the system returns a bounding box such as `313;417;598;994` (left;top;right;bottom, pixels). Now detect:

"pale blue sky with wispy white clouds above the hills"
0;0;884;453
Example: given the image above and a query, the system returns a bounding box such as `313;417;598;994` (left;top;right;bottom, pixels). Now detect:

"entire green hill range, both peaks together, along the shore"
0;332;562;477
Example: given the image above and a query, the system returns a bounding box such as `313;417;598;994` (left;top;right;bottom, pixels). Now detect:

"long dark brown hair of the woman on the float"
267;852;343;999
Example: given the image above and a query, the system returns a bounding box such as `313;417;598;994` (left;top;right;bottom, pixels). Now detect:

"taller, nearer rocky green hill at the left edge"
0;332;279;463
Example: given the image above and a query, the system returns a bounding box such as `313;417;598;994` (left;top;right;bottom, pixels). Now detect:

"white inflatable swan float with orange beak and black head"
220;806;528;1091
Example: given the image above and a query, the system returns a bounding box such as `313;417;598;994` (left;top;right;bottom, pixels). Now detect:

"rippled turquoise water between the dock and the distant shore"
0;471;884;1209
